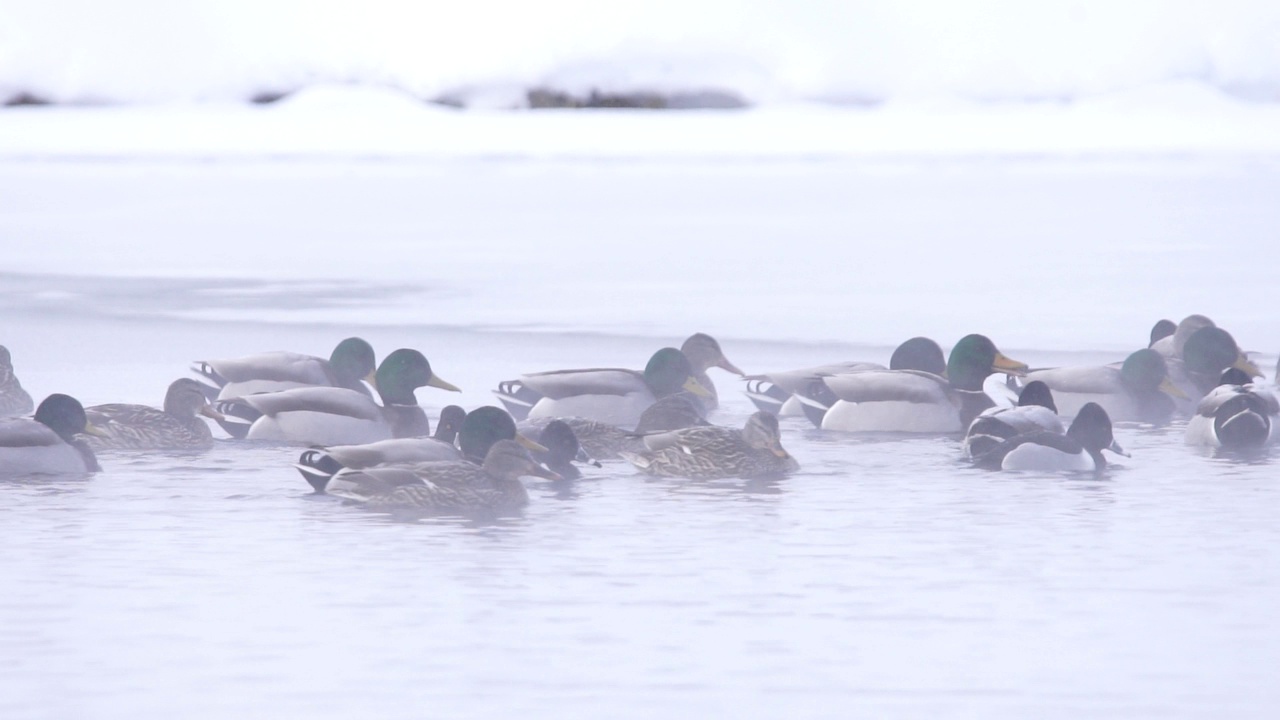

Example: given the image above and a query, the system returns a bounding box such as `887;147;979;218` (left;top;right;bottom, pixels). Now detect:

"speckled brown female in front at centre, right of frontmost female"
622;411;800;479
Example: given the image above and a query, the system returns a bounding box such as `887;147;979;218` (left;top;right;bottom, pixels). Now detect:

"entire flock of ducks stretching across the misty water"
0;315;1280;514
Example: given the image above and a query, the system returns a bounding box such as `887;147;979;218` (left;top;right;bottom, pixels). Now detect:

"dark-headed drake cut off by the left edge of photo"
0;393;102;477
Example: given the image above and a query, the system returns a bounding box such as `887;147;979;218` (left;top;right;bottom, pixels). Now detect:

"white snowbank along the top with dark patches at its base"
0;0;1280;104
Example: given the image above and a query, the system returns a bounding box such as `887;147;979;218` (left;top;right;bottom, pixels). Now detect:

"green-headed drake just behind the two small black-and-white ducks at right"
1027;347;1187;425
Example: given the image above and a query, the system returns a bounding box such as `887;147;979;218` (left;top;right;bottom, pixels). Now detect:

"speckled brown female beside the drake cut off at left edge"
84;378;227;450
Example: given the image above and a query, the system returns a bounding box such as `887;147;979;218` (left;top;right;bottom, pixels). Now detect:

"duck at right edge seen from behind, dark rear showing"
1184;368;1280;450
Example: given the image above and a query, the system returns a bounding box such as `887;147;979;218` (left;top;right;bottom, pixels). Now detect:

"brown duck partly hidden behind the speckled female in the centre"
520;392;708;460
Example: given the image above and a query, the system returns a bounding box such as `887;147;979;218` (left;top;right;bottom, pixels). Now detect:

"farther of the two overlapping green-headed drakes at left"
192;337;376;400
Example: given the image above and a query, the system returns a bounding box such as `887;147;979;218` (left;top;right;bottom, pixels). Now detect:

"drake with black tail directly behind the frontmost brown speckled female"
294;405;545;492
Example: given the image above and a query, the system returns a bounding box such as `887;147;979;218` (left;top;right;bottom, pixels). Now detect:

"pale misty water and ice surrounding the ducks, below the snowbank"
0;155;1280;717
